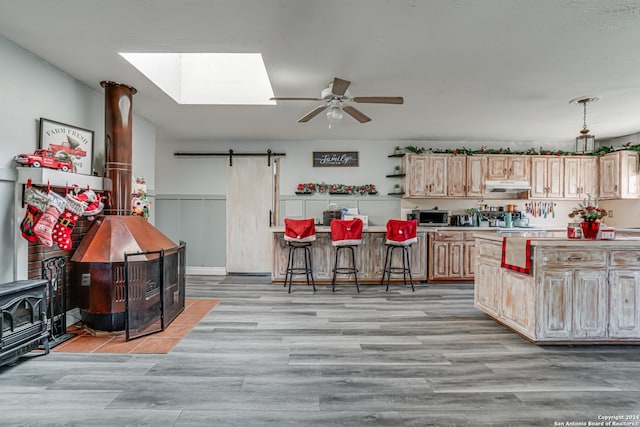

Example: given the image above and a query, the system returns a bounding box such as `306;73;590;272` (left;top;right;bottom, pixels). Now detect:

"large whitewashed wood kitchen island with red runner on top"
474;232;640;344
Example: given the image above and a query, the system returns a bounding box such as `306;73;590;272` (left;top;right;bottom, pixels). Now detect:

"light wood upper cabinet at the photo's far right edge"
600;151;640;199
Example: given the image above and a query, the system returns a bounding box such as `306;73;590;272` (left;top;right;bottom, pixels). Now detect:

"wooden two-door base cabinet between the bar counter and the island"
427;230;475;282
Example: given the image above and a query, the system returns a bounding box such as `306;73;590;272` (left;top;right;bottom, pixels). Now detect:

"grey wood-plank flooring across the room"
0;276;640;427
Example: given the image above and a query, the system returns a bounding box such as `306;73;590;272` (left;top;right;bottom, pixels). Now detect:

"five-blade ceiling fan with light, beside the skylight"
271;77;404;124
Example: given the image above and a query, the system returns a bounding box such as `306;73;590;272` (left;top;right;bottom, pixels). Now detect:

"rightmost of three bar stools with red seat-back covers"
380;219;418;292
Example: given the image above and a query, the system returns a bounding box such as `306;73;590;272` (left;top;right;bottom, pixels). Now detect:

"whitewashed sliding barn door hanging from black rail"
227;157;278;274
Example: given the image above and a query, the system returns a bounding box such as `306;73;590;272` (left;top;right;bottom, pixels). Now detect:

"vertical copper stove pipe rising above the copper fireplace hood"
100;81;137;215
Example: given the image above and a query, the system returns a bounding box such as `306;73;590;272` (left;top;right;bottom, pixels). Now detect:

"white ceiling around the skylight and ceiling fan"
0;0;640;147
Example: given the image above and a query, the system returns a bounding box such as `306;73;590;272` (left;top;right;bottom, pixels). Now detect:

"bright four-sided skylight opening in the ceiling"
120;53;276;105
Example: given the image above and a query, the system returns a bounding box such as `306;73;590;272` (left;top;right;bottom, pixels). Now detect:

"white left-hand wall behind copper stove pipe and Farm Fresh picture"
0;37;155;283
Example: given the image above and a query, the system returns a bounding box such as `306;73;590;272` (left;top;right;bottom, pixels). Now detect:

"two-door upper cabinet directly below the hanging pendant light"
564;156;600;199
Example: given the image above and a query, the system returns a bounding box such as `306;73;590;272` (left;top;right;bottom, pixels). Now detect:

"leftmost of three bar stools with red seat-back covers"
284;218;316;293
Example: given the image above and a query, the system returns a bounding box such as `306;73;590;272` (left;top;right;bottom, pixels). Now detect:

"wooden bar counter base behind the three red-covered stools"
271;226;427;284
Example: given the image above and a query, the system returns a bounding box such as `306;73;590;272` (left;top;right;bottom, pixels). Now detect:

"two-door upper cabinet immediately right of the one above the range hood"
530;156;564;199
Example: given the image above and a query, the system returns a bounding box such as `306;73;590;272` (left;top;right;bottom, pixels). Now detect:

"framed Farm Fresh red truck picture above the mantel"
39;117;94;175
